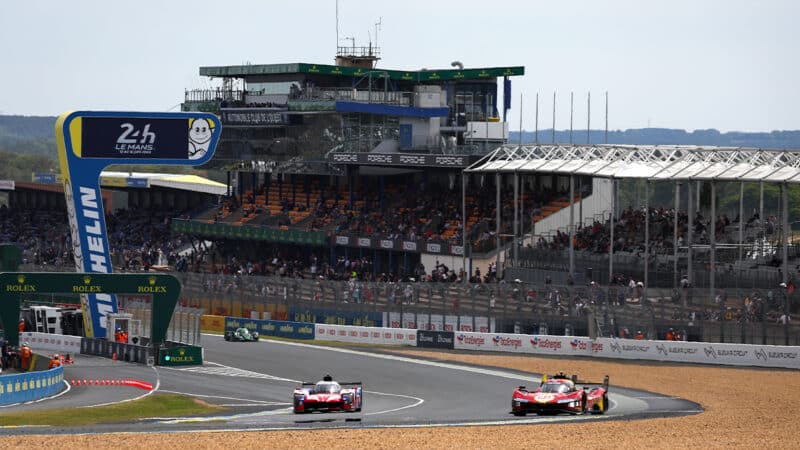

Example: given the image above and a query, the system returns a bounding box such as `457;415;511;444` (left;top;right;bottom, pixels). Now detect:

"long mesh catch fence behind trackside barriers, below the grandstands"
181;274;800;345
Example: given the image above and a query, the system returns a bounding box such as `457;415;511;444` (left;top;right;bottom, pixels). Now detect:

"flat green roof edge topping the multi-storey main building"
200;63;525;82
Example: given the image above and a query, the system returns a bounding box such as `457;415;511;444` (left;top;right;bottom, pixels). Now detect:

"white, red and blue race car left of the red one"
292;375;364;414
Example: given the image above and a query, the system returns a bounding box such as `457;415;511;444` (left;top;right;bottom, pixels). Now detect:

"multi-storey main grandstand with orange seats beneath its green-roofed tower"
177;47;536;276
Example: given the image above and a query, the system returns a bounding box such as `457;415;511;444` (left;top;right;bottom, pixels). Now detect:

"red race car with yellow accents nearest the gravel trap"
511;372;609;416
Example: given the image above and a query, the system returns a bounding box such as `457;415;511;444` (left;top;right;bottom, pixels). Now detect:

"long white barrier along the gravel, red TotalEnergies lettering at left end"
454;332;800;369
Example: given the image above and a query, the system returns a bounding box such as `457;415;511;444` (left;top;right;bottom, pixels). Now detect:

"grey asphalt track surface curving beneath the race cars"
0;335;702;435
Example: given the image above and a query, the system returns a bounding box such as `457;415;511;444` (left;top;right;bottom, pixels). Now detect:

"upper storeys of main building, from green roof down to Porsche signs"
182;56;525;169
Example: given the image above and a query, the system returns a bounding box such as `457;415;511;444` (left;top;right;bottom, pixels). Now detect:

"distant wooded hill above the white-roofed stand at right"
508;128;800;150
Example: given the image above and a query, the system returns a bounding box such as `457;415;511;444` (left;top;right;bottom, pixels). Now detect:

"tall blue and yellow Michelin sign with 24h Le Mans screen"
55;111;222;338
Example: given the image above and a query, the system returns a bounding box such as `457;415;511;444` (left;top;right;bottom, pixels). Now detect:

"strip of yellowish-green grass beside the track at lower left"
0;394;227;426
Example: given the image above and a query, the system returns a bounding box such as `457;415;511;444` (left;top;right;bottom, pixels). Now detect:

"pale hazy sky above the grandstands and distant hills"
0;0;800;132
